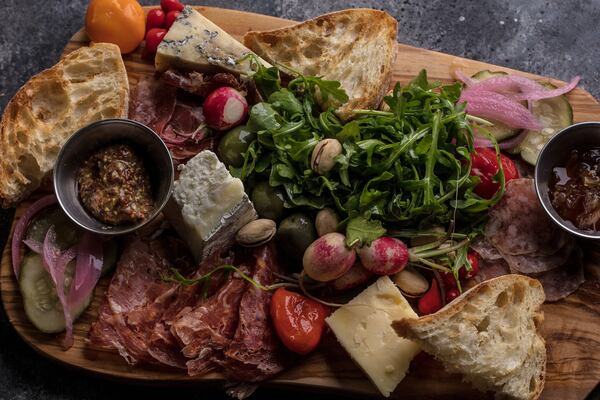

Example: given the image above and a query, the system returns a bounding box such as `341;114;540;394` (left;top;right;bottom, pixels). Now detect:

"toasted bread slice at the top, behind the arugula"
244;8;398;119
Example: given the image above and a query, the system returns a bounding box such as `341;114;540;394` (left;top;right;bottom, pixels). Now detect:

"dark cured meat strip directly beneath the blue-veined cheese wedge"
162;69;244;97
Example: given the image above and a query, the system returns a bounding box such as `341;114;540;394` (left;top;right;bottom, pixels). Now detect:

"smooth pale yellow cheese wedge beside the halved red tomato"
326;276;420;397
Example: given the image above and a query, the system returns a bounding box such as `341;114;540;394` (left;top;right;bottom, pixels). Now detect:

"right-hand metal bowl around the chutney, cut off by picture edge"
534;122;600;239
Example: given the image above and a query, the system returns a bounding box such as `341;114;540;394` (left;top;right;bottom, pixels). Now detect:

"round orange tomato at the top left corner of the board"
85;0;146;54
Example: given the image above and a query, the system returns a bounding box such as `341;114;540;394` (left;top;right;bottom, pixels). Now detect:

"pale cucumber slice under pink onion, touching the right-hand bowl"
517;83;573;165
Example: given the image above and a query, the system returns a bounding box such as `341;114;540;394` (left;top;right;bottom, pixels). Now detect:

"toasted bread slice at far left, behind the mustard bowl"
0;43;129;207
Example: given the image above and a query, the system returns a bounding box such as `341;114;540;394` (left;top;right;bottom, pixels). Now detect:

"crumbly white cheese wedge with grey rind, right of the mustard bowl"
165;150;257;262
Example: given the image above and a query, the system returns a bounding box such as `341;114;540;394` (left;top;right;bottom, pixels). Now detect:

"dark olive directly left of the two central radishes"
275;213;317;271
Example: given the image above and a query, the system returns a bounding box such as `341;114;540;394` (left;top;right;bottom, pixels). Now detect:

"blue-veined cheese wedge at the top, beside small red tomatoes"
154;6;271;75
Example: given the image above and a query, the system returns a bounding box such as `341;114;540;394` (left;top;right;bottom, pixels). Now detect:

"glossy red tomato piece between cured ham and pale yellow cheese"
271;288;329;354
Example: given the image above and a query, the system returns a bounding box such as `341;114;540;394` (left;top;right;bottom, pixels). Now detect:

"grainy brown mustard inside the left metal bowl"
77;144;154;225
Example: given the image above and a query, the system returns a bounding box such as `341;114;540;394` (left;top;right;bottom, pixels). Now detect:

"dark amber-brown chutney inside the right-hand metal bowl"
549;148;600;231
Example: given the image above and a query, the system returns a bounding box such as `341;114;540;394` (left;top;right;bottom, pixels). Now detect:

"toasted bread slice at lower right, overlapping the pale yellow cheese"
392;275;546;399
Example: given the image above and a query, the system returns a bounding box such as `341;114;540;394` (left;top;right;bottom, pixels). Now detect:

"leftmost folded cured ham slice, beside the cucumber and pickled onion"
89;239;195;367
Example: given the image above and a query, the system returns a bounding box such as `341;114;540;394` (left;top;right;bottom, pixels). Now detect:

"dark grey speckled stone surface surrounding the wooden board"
0;0;600;400
